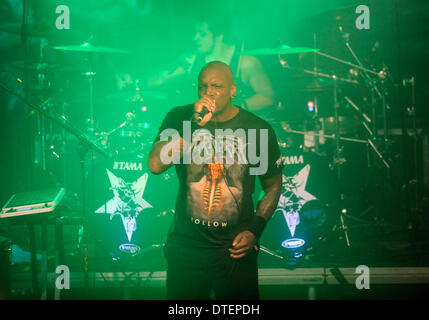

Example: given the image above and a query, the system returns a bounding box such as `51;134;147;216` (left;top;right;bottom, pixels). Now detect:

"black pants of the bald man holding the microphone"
165;243;259;300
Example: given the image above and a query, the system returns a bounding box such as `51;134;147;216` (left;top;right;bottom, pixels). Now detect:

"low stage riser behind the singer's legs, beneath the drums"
7;267;429;299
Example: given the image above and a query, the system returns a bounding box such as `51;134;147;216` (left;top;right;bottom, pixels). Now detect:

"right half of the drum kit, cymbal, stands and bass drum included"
237;35;391;267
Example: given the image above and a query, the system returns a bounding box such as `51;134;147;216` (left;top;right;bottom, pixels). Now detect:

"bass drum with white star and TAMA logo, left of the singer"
90;153;178;260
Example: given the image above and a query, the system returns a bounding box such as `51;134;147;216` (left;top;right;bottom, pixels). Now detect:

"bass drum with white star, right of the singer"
260;149;339;265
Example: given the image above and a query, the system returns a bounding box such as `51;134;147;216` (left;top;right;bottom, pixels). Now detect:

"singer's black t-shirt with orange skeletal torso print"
155;105;282;247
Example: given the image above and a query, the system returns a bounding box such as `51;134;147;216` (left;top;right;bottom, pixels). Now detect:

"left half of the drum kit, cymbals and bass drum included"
3;39;177;266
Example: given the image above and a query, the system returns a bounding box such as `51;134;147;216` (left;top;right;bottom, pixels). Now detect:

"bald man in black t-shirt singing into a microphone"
148;61;282;299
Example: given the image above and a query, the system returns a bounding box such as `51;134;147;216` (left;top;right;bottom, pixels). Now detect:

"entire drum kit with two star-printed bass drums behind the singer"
5;27;390;263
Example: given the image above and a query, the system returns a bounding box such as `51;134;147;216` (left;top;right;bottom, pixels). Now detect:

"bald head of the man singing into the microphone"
198;61;237;114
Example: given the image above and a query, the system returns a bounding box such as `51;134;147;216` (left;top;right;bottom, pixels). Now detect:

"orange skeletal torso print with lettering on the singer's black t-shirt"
187;132;248;228
